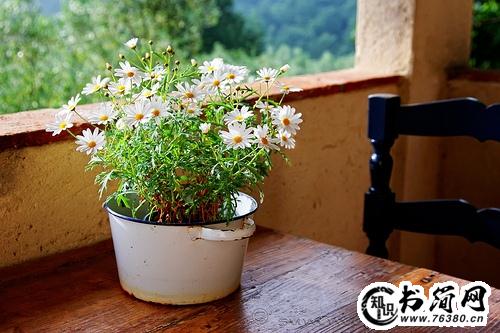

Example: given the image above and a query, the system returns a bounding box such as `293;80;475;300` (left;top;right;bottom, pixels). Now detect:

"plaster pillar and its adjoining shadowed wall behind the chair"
356;0;500;286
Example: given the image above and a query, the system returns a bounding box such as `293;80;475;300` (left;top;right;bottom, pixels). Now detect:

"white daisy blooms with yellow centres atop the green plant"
47;38;302;154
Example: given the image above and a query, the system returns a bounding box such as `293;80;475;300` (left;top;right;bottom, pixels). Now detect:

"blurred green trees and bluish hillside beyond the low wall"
0;0;356;113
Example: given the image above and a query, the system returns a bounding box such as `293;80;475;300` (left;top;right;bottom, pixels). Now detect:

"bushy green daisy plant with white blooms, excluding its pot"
47;38;302;223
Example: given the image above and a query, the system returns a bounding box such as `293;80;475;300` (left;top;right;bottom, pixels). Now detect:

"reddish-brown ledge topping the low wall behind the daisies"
0;69;403;150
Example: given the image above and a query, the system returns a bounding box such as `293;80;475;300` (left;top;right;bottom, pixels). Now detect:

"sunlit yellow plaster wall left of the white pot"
0;141;109;267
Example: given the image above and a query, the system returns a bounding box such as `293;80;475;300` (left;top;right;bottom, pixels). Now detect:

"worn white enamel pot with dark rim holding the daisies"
105;193;258;304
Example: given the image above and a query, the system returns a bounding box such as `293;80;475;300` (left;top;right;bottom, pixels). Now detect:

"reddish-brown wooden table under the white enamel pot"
0;228;500;332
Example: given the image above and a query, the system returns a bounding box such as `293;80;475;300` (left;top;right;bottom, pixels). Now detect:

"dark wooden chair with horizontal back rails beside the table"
363;94;500;258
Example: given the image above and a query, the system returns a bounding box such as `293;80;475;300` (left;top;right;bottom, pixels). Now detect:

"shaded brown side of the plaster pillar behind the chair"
394;0;473;269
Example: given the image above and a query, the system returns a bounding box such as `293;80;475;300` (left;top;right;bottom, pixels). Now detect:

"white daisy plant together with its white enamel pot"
47;38;302;304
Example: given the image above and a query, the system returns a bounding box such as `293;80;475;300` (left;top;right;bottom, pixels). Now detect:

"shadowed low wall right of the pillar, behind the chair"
437;80;500;287
